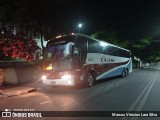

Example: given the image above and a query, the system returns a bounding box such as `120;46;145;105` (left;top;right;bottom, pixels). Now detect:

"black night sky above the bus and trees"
47;0;160;39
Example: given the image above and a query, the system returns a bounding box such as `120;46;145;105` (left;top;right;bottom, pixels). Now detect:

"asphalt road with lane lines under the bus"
0;65;160;120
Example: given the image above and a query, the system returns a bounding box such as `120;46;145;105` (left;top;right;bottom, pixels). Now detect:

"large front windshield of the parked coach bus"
47;42;72;70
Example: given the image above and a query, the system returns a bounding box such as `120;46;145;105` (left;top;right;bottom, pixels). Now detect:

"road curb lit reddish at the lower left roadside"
0;88;37;99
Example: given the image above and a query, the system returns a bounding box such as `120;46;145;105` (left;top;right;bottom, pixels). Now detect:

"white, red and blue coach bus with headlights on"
42;33;132;87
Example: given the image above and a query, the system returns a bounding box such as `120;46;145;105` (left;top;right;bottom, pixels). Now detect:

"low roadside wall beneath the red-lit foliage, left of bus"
0;67;41;86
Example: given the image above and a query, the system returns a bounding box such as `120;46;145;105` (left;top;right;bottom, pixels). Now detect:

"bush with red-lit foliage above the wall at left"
0;26;39;61
